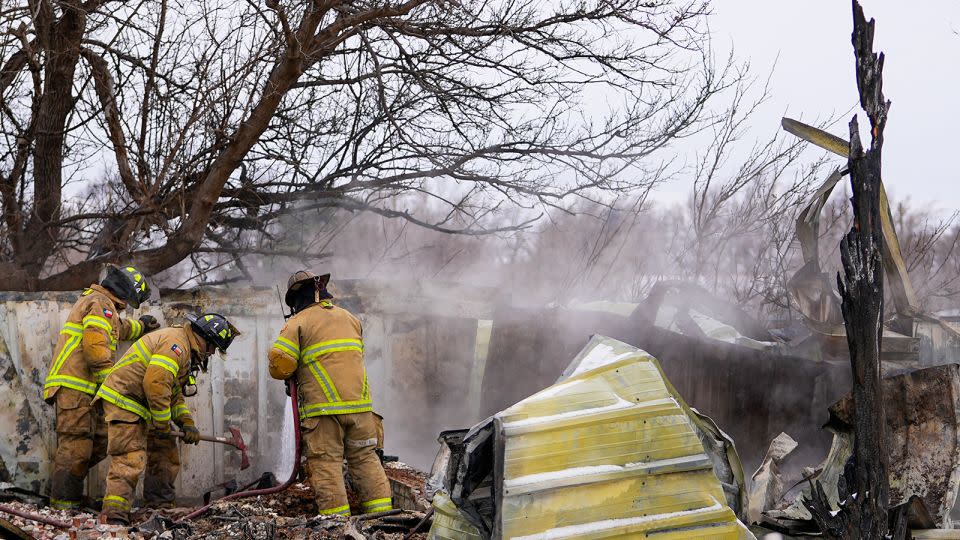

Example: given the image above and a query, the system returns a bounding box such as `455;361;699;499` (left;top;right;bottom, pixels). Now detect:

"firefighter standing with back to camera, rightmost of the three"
268;270;393;516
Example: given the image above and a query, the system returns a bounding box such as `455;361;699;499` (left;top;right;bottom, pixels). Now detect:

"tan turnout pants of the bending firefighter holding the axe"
103;403;180;522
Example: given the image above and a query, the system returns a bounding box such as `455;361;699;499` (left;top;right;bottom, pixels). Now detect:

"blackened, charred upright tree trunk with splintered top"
809;0;907;538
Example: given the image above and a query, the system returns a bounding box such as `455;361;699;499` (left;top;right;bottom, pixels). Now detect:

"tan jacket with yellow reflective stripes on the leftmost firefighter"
43;285;143;401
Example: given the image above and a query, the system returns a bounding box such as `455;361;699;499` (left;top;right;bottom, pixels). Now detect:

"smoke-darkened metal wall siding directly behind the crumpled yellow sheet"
481;308;850;470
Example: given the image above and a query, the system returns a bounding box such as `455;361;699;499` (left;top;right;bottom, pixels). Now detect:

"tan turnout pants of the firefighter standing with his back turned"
301;412;393;516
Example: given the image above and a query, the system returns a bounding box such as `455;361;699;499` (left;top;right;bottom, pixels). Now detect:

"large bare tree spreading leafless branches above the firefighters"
0;0;743;290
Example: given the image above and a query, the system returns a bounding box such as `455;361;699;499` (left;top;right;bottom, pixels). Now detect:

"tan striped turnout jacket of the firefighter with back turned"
269;300;373;418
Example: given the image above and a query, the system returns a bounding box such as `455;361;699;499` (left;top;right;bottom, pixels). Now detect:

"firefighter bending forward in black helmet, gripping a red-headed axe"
96;313;239;523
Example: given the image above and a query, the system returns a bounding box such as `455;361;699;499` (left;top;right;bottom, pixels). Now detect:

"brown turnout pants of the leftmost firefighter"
50;387;107;508
